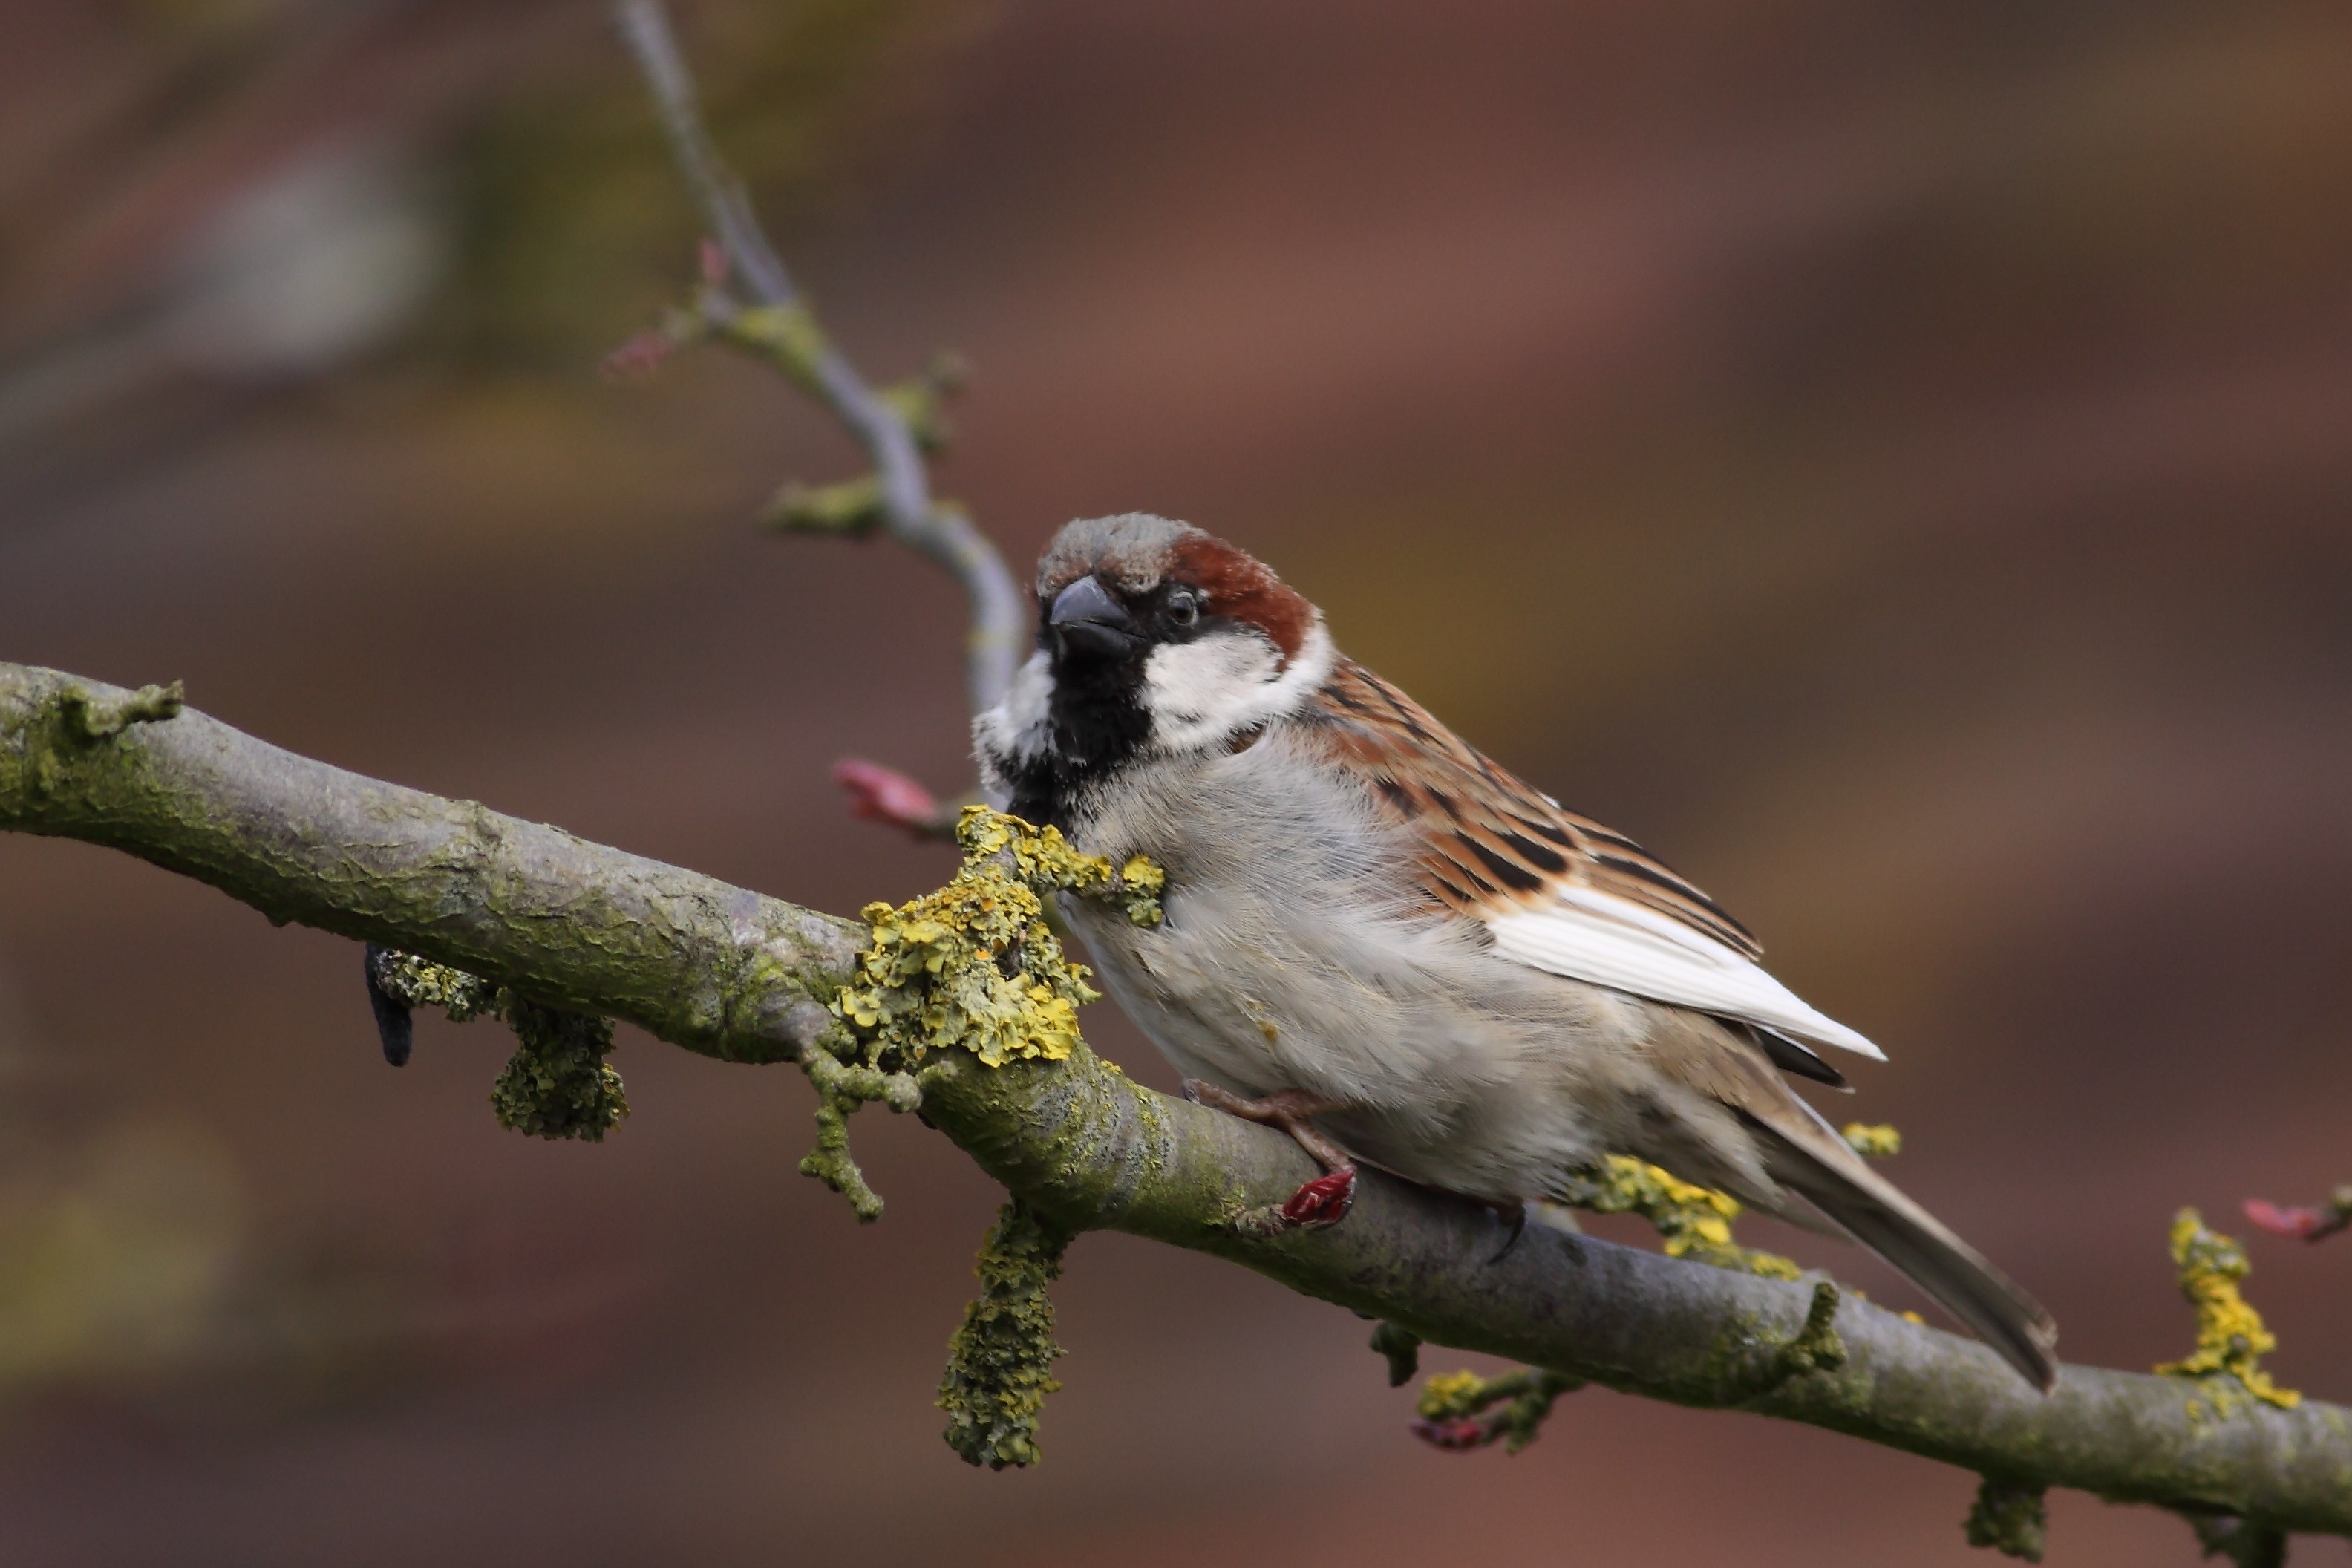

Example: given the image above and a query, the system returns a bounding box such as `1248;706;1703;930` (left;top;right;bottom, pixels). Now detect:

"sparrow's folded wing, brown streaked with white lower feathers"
1310;659;1884;1058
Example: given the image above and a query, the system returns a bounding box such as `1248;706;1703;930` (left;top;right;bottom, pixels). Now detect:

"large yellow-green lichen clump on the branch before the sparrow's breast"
800;806;1164;1220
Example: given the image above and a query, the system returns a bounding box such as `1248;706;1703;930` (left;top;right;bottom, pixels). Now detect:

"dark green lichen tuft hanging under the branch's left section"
374;952;628;1143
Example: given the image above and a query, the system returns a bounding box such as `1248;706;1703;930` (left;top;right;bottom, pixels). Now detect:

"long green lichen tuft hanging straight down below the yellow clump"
938;1199;1070;1469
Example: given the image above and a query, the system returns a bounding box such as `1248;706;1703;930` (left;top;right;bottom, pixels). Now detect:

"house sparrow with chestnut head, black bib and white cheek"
974;514;2058;1389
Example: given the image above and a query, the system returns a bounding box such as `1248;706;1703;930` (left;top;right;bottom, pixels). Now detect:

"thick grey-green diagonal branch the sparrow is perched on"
0;665;2352;1535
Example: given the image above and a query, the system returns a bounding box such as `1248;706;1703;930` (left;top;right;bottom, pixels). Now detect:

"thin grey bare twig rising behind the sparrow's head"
612;0;1028;712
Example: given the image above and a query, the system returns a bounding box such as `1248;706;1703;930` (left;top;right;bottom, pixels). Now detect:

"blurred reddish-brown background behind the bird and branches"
0;0;2352;1568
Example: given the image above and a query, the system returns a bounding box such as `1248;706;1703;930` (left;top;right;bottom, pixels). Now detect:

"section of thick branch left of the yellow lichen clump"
0;665;866;1062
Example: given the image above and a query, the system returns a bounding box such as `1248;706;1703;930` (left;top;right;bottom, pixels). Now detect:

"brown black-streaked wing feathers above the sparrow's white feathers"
1313;659;1764;959
